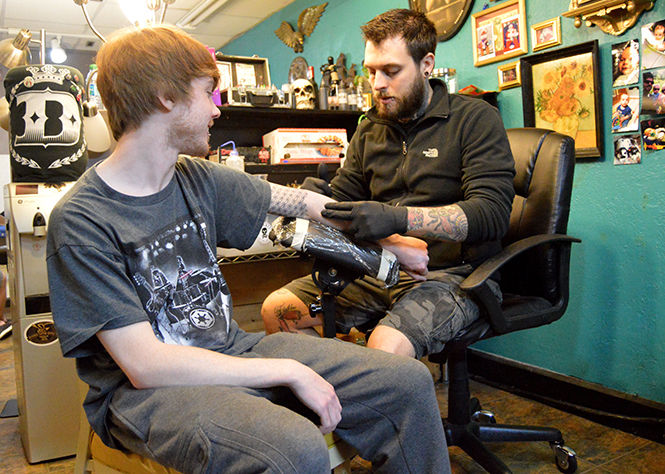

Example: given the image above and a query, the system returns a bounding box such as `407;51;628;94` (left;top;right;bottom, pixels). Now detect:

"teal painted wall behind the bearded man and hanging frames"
222;0;665;402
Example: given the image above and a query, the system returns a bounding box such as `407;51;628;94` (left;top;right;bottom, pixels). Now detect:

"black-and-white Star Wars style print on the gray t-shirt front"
132;216;231;349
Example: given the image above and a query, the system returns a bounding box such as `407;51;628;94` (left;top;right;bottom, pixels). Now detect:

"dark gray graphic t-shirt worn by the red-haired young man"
47;157;270;445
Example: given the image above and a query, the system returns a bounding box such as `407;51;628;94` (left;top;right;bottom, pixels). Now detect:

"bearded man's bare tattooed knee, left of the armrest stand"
261;288;313;334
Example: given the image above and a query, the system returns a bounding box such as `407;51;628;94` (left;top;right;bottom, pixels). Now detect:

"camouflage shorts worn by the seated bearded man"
286;265;501;358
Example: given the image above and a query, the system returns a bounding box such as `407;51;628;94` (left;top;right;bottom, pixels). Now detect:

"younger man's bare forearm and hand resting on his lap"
97;322;342;433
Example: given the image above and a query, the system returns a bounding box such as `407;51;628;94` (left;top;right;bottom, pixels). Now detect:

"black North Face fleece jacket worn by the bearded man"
330;79;515;269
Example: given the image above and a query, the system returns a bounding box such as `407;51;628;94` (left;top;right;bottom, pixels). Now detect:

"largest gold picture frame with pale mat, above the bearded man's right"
471;0;529;67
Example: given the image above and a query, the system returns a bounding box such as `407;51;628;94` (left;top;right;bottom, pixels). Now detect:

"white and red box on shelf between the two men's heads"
263;128;349;164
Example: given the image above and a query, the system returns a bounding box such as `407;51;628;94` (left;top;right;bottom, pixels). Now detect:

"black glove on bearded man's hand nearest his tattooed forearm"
321;201;408;241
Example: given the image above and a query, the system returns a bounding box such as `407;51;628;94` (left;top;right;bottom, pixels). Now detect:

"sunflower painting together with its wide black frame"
520;40;603;158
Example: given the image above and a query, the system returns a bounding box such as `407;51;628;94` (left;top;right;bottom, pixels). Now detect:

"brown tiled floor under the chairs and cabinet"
0;312;665;474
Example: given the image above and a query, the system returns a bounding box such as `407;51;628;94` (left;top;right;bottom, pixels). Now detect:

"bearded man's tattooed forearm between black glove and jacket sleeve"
408;205;469;242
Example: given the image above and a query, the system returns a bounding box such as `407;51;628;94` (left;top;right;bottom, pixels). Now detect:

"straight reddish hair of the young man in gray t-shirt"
96;26;219;140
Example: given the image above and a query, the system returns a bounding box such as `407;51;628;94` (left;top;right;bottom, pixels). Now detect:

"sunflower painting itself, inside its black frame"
532;53;596;148
